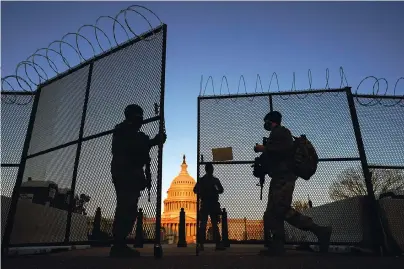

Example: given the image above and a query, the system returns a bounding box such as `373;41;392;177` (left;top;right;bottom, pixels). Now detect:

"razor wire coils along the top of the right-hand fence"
199;67;404;107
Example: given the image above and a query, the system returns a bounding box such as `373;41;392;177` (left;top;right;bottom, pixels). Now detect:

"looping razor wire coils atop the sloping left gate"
1;5;163;105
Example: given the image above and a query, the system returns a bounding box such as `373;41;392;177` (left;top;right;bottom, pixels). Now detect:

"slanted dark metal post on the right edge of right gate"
345;87;384;255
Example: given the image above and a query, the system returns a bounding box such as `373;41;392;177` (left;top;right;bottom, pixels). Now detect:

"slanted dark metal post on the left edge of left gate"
1;87;42;254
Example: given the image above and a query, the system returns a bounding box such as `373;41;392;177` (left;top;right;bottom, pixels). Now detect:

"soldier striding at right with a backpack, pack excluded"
254;111;332;255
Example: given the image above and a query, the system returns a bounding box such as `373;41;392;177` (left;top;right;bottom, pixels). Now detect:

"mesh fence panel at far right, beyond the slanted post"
355;96;404;252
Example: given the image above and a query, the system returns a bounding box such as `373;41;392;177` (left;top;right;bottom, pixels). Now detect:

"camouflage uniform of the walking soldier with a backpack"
264;125;324;248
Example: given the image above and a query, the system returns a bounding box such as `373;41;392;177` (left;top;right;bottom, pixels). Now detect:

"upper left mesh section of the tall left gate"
28;66;89;156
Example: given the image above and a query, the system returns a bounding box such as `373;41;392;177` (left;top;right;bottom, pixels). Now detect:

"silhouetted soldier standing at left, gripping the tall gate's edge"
110;104;166;257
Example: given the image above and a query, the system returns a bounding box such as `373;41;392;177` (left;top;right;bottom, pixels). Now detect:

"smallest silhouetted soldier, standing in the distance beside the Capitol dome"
194;163;226;251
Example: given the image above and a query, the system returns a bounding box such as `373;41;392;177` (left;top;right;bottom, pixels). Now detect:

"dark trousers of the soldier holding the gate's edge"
113;178;140;245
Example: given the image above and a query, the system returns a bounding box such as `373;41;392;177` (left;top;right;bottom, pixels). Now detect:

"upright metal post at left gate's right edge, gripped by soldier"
154;24;167;258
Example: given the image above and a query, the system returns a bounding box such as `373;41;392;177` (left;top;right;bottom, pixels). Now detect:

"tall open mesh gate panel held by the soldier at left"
2;24;167;255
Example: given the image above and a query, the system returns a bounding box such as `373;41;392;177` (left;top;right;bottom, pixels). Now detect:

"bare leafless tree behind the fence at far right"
329;167;404;201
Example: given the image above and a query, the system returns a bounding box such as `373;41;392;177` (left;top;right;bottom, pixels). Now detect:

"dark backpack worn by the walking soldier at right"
293;135;318;180
